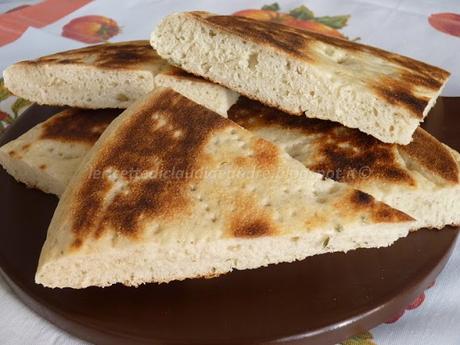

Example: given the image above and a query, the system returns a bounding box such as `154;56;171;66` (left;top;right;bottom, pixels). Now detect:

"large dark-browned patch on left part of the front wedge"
72;90;233;245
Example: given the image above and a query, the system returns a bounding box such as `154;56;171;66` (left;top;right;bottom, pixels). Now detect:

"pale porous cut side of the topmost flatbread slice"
150;13;446;145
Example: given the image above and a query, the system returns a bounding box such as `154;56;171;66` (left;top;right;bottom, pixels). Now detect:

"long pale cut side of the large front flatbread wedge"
35;220;408;289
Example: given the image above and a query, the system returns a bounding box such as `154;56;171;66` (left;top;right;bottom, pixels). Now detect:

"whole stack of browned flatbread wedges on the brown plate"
0;12;454;288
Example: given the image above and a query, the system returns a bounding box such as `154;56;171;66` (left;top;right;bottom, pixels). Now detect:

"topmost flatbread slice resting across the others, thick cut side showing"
151;12;449;145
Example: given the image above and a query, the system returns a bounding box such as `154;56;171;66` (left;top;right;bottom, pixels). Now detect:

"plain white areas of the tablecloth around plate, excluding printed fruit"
0;0;460;345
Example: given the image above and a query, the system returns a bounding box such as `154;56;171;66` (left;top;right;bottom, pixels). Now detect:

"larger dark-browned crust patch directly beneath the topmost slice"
228;97;416;186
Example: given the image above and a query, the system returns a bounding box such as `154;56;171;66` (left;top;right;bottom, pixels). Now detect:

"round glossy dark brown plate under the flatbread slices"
0;98;460;345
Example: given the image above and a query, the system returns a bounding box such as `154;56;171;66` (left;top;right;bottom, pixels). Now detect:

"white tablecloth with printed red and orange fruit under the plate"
0;0;460;345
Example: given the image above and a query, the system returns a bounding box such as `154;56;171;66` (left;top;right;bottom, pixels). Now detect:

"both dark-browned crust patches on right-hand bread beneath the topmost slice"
228;97;459;187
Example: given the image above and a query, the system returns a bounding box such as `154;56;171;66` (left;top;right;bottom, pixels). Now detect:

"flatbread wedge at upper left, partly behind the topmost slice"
3;41;168;109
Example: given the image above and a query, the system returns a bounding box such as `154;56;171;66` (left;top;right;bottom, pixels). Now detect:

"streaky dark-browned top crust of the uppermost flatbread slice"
189;12;450;119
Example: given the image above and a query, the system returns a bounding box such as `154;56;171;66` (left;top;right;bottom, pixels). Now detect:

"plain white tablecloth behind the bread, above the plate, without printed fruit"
0;0;460;96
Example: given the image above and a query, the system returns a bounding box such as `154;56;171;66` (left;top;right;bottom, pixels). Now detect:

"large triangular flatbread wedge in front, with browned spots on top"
35;89;413;288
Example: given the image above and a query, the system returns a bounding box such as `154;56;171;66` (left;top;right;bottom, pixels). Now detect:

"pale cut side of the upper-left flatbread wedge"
3;63;158;109
